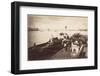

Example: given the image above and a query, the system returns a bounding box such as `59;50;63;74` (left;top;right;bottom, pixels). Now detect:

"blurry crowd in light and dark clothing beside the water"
49;33;88;56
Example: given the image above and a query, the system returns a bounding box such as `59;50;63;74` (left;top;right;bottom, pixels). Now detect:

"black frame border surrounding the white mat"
11;1;98;74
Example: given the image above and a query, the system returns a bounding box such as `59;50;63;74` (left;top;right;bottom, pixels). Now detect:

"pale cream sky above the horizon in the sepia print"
27;14;88;30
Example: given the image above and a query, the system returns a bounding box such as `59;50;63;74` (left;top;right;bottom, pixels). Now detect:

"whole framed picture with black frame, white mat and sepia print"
11;1;98;74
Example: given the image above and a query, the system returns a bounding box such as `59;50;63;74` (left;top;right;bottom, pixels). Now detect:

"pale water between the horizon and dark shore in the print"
28;31;88;47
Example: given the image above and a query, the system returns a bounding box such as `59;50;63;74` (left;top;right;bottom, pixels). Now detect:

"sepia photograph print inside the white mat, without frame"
27;14;88;60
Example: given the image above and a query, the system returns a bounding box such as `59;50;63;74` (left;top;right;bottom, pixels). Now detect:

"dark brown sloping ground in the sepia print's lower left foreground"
28;43;87;60
